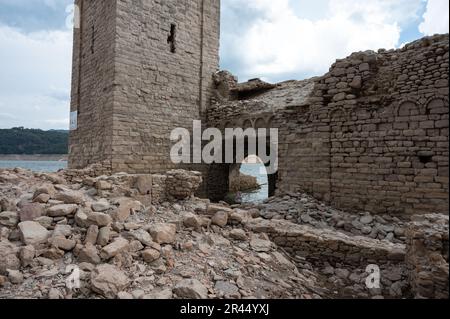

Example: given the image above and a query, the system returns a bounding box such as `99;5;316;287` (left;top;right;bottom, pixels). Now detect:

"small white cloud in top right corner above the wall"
419;0;449;35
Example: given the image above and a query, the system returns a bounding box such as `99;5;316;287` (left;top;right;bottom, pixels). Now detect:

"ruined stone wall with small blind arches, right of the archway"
277;35;449;214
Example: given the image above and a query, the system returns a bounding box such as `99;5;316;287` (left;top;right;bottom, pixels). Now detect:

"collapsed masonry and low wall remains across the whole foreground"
0;167;449;299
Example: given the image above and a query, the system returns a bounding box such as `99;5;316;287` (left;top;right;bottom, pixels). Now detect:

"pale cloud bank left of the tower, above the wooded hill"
0;24;72;129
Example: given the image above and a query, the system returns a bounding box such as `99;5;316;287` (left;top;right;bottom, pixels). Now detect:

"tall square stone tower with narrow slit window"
69;0;220;173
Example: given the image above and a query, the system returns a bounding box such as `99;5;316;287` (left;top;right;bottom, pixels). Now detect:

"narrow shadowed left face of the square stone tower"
69;0;116;168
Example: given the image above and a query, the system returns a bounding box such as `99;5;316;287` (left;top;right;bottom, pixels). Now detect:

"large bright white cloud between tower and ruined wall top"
224;0;423;79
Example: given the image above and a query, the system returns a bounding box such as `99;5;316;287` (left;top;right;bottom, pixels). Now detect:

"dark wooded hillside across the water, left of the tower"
0;127;69;155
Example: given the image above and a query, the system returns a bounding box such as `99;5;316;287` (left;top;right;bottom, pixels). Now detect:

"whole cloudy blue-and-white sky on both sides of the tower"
0;0;449;129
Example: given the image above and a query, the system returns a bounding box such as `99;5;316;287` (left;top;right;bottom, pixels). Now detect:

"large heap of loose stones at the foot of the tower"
0;169;324;299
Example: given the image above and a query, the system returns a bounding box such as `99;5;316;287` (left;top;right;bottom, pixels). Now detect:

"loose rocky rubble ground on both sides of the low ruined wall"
0;169;440;299
